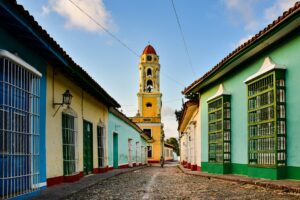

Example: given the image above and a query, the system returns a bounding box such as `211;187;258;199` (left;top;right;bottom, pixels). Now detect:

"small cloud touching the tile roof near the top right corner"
264;0;298;22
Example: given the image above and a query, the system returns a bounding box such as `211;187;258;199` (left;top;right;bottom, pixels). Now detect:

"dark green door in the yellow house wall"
83;121;93;174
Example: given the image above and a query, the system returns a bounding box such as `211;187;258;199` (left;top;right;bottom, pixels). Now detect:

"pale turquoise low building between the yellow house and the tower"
108;108;150;169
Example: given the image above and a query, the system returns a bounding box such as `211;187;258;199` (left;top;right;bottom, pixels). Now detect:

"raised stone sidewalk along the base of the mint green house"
178;165;300;193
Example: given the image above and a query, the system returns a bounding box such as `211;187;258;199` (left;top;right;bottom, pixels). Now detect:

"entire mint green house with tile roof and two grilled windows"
183;3;300;180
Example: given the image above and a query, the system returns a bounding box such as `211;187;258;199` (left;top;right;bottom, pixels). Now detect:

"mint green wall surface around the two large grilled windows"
200;30;300;179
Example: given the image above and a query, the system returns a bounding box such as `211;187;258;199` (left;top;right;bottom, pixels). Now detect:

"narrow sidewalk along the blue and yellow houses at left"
32;166;147;200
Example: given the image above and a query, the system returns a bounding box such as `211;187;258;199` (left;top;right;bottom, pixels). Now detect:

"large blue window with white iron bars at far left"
0;50;41;198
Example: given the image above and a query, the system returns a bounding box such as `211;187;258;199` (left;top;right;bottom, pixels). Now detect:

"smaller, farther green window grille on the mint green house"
208;95;231;163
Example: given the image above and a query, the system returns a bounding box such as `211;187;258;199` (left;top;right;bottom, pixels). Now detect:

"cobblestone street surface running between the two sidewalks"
68;166;300;200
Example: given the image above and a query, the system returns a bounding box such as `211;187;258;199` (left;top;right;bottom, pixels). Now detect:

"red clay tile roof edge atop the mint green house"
182;1;300;94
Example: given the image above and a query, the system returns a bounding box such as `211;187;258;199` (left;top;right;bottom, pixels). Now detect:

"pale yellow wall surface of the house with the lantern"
46;66;108;178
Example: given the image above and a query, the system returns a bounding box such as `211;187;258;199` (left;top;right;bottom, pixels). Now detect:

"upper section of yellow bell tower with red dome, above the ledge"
137;45;162;118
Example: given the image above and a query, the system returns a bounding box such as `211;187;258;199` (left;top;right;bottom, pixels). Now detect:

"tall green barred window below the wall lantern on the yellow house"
62;113;77;175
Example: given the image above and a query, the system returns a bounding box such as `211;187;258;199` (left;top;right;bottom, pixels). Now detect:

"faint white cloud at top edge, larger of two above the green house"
223;0;259;31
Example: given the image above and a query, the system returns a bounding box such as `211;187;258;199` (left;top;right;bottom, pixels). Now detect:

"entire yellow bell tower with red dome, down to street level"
131;45;164;163
